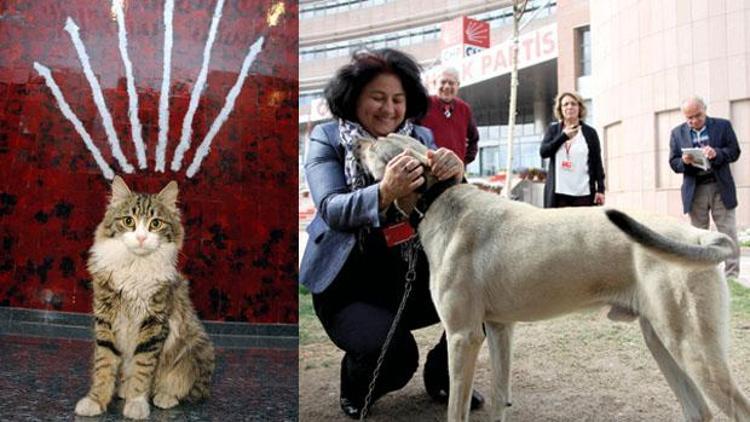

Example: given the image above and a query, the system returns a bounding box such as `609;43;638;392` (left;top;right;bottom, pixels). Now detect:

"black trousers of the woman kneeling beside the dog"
313;230;448;405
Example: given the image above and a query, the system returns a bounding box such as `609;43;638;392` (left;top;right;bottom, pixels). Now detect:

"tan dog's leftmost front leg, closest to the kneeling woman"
446;326;484;422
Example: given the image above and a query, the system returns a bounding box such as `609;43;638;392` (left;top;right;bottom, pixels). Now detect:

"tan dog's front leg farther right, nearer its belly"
485;321;513;422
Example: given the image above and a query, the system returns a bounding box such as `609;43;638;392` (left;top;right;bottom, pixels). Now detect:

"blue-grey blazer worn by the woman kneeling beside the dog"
299;122;435;293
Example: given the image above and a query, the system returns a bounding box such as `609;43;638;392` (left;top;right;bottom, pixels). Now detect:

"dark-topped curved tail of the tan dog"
605;209;734;264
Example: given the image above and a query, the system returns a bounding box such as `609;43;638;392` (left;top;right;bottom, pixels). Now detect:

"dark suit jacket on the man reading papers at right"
669;117;740;214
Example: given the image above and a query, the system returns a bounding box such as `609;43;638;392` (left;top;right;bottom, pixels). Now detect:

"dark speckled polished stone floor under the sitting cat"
0;335;299;422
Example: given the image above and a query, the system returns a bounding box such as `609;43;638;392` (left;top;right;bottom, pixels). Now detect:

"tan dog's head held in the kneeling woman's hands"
353;133;437;192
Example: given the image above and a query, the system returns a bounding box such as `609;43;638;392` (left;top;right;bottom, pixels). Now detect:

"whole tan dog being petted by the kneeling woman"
355;136;750;421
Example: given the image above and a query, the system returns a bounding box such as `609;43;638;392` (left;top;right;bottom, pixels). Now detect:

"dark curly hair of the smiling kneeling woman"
324;48;429;122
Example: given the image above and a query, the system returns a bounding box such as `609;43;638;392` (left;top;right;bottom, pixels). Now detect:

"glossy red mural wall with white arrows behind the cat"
0;0;298;323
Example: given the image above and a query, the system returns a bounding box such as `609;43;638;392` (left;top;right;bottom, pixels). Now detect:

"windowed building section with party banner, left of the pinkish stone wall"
299;0;557;176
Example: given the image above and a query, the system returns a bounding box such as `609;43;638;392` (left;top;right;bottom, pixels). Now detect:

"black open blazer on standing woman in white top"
539;122;604;208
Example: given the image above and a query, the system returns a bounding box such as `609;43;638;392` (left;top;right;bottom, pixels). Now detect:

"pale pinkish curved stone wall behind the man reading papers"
592;0;750;227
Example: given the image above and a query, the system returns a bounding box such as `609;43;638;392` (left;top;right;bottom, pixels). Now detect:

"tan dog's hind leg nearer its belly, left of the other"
639;317;711;422
